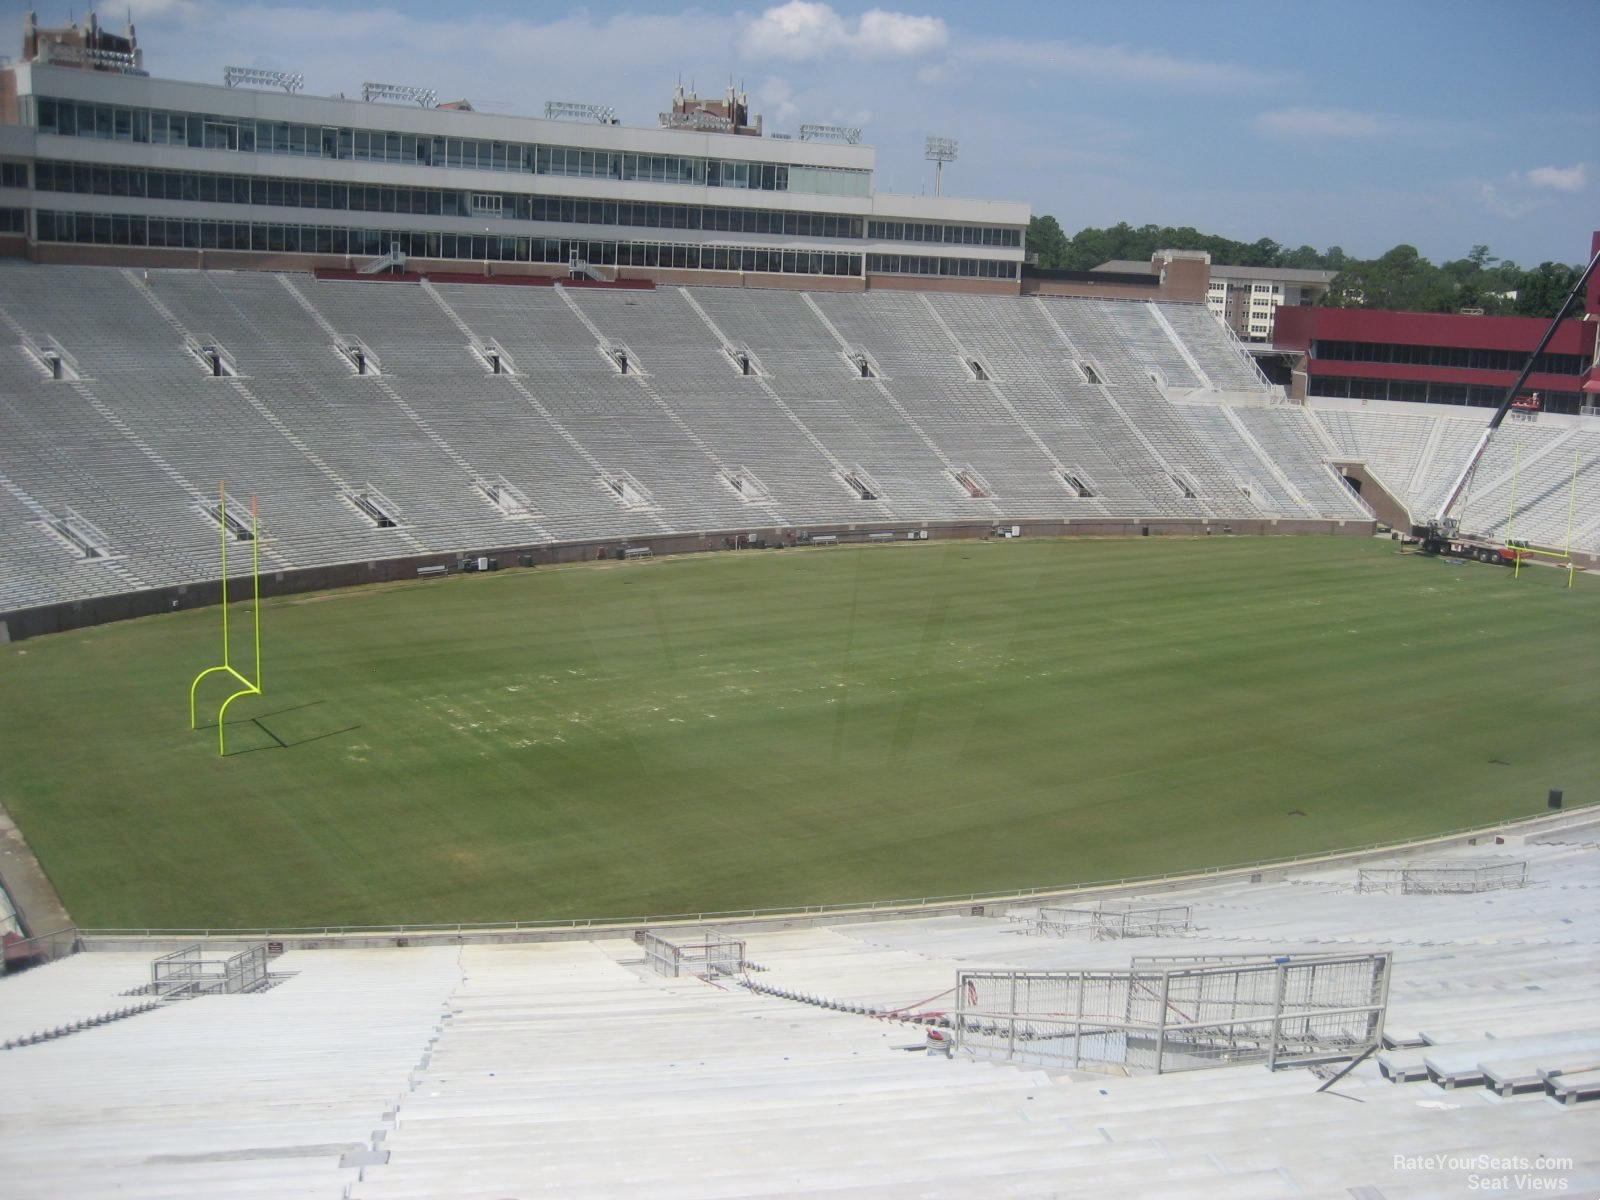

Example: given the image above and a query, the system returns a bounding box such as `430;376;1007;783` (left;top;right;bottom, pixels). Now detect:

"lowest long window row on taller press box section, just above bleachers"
28;210;861;277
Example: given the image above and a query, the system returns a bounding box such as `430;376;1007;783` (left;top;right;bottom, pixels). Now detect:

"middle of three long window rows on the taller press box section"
35;160;862;238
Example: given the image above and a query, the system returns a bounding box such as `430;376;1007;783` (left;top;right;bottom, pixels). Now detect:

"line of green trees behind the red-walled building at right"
1027;214;1582;317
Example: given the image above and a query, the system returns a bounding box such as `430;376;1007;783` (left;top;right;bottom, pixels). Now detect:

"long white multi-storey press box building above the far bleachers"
0;61;1029;293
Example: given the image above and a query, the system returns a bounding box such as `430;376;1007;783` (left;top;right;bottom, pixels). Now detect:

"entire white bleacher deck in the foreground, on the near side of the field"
0;814;1600;1200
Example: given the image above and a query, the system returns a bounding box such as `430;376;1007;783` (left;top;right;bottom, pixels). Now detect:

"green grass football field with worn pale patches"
0;538;1600;926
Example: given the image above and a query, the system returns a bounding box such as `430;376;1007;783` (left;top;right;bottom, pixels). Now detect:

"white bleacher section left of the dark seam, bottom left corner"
0;950;461;1200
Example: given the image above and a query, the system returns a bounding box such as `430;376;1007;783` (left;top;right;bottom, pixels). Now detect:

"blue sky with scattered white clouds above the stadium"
9;0;1600;266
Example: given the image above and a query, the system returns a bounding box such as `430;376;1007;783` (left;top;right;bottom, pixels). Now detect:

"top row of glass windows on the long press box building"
24;96;872;195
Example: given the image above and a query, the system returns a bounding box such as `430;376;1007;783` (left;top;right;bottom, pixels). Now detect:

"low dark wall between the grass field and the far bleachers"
0;517;1376;643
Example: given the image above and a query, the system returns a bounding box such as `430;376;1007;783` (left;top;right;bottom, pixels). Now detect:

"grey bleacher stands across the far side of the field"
0;262;1600;611
